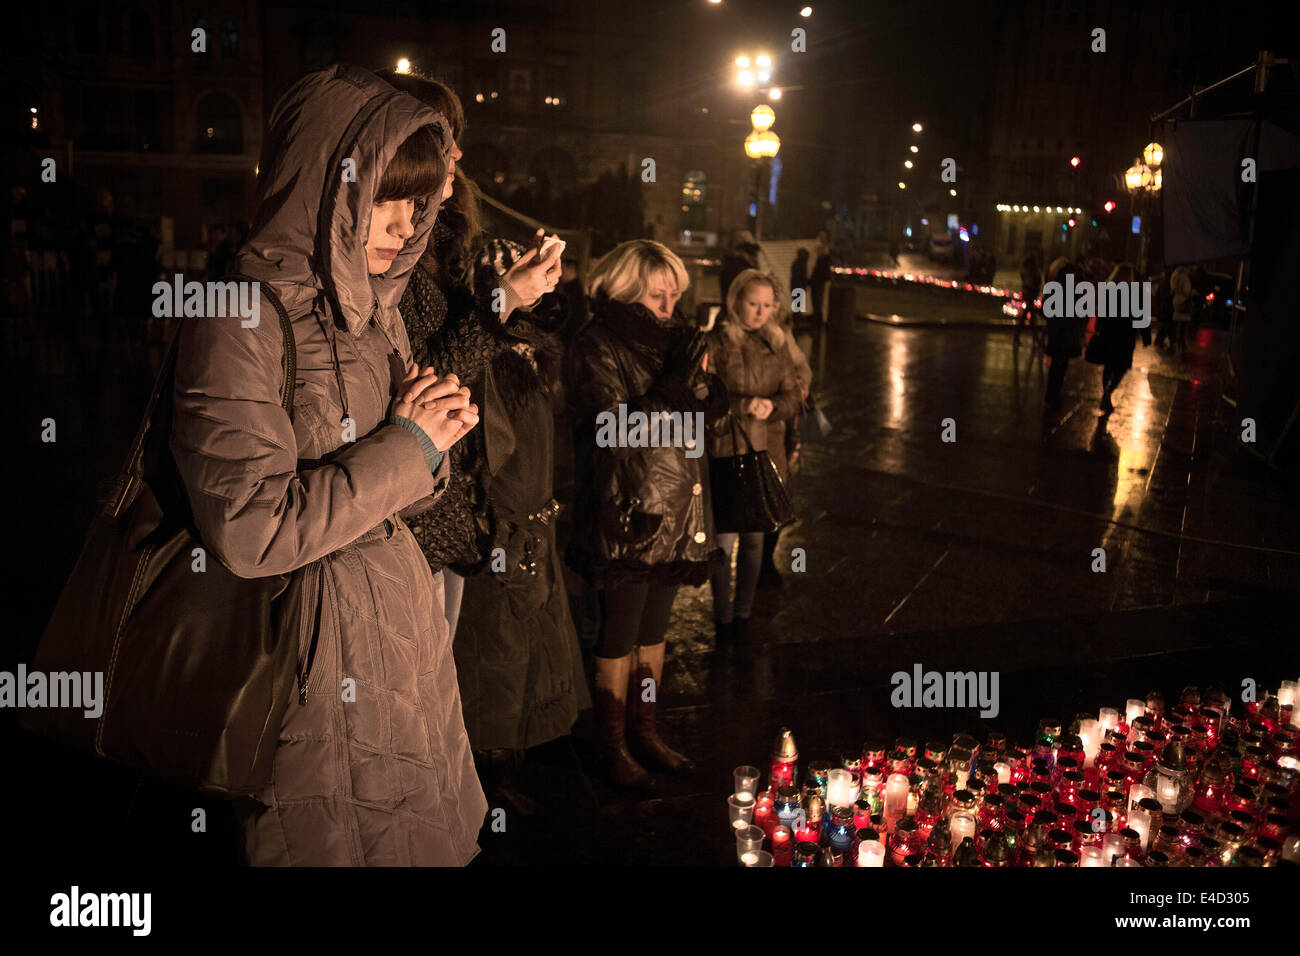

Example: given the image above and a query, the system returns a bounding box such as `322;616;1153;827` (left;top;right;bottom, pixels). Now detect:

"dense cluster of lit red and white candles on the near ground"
728;680;1300;866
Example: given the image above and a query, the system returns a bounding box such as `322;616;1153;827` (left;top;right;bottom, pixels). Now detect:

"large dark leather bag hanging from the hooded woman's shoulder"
23;276;313;799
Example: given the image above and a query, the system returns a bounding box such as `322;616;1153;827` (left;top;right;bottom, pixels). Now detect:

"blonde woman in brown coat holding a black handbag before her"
709;269;802;646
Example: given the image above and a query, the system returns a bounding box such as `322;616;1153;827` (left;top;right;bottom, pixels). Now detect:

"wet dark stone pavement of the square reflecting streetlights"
10;291;1300;866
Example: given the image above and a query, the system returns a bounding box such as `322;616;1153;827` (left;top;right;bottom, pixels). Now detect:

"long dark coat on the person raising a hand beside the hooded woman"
403;242;590;750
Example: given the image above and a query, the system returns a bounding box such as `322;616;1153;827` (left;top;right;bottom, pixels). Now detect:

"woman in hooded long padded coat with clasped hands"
163;66;488;866
